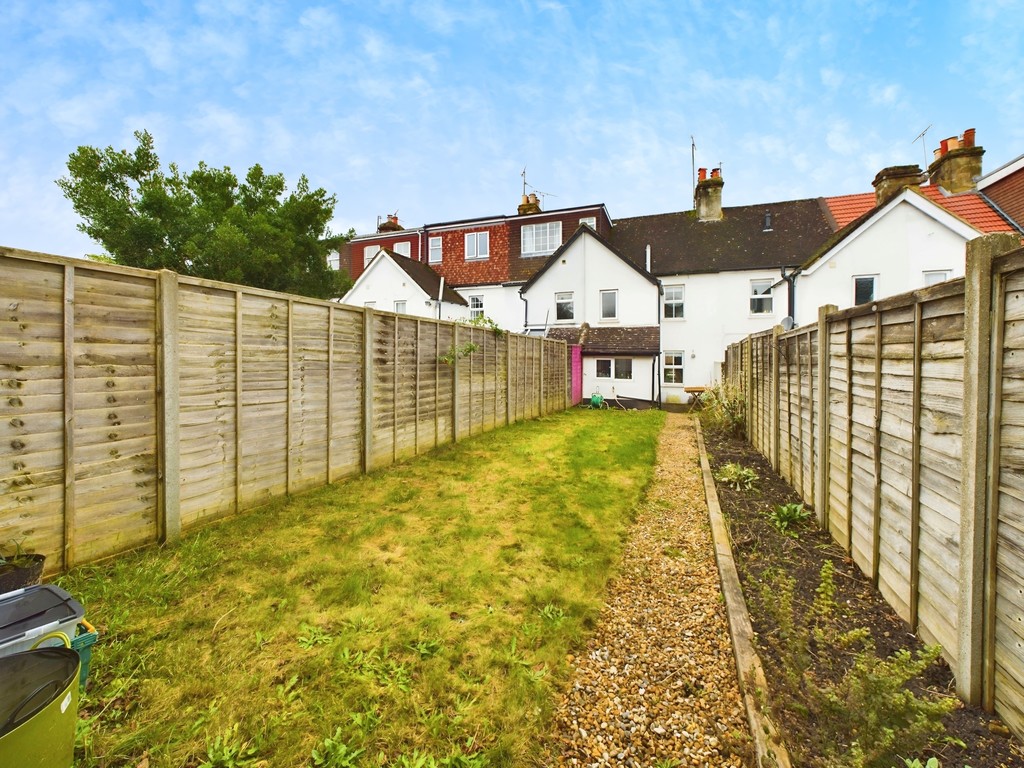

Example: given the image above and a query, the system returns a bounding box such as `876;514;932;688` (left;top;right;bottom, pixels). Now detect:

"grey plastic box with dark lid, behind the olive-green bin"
0;584;85;656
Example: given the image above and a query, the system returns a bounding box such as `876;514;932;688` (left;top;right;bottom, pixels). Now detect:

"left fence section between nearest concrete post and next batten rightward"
178;284;239;527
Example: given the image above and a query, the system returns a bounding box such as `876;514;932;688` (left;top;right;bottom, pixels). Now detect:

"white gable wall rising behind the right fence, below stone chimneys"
796;193;979;326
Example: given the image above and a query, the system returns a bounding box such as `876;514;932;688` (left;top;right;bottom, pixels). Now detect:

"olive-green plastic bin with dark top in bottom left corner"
0;648;82;768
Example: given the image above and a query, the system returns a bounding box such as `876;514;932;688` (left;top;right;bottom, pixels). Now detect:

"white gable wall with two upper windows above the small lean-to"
526;234;658;329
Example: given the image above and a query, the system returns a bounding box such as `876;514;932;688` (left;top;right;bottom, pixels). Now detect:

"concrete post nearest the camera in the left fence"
157;269;181;542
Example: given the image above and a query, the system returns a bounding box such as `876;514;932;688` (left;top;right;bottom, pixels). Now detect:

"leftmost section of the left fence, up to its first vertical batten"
0;256;74;564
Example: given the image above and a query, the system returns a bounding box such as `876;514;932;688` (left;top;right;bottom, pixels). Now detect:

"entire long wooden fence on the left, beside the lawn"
0;249;569;571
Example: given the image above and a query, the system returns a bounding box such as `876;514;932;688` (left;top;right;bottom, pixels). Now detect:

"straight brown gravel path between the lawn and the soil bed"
549;414;754;768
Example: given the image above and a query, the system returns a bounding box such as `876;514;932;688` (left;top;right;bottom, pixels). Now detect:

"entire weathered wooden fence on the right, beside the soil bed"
724;236;1024;735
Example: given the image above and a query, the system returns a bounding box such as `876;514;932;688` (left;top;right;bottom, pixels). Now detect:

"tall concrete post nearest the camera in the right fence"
955;234;1019;707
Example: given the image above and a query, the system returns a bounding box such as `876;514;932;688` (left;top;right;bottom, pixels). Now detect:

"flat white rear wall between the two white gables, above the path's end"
662;269;788;402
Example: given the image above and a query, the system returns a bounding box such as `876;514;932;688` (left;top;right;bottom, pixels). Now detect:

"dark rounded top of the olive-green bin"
0;648;81;736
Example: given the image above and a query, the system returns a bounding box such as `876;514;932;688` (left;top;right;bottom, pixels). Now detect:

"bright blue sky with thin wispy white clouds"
0;0;1024;256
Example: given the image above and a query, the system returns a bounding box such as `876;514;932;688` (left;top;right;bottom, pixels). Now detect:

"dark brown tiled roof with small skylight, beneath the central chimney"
610;198;834;274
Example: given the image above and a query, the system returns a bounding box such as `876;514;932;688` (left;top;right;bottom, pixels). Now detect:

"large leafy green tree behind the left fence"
56;131;350;298
